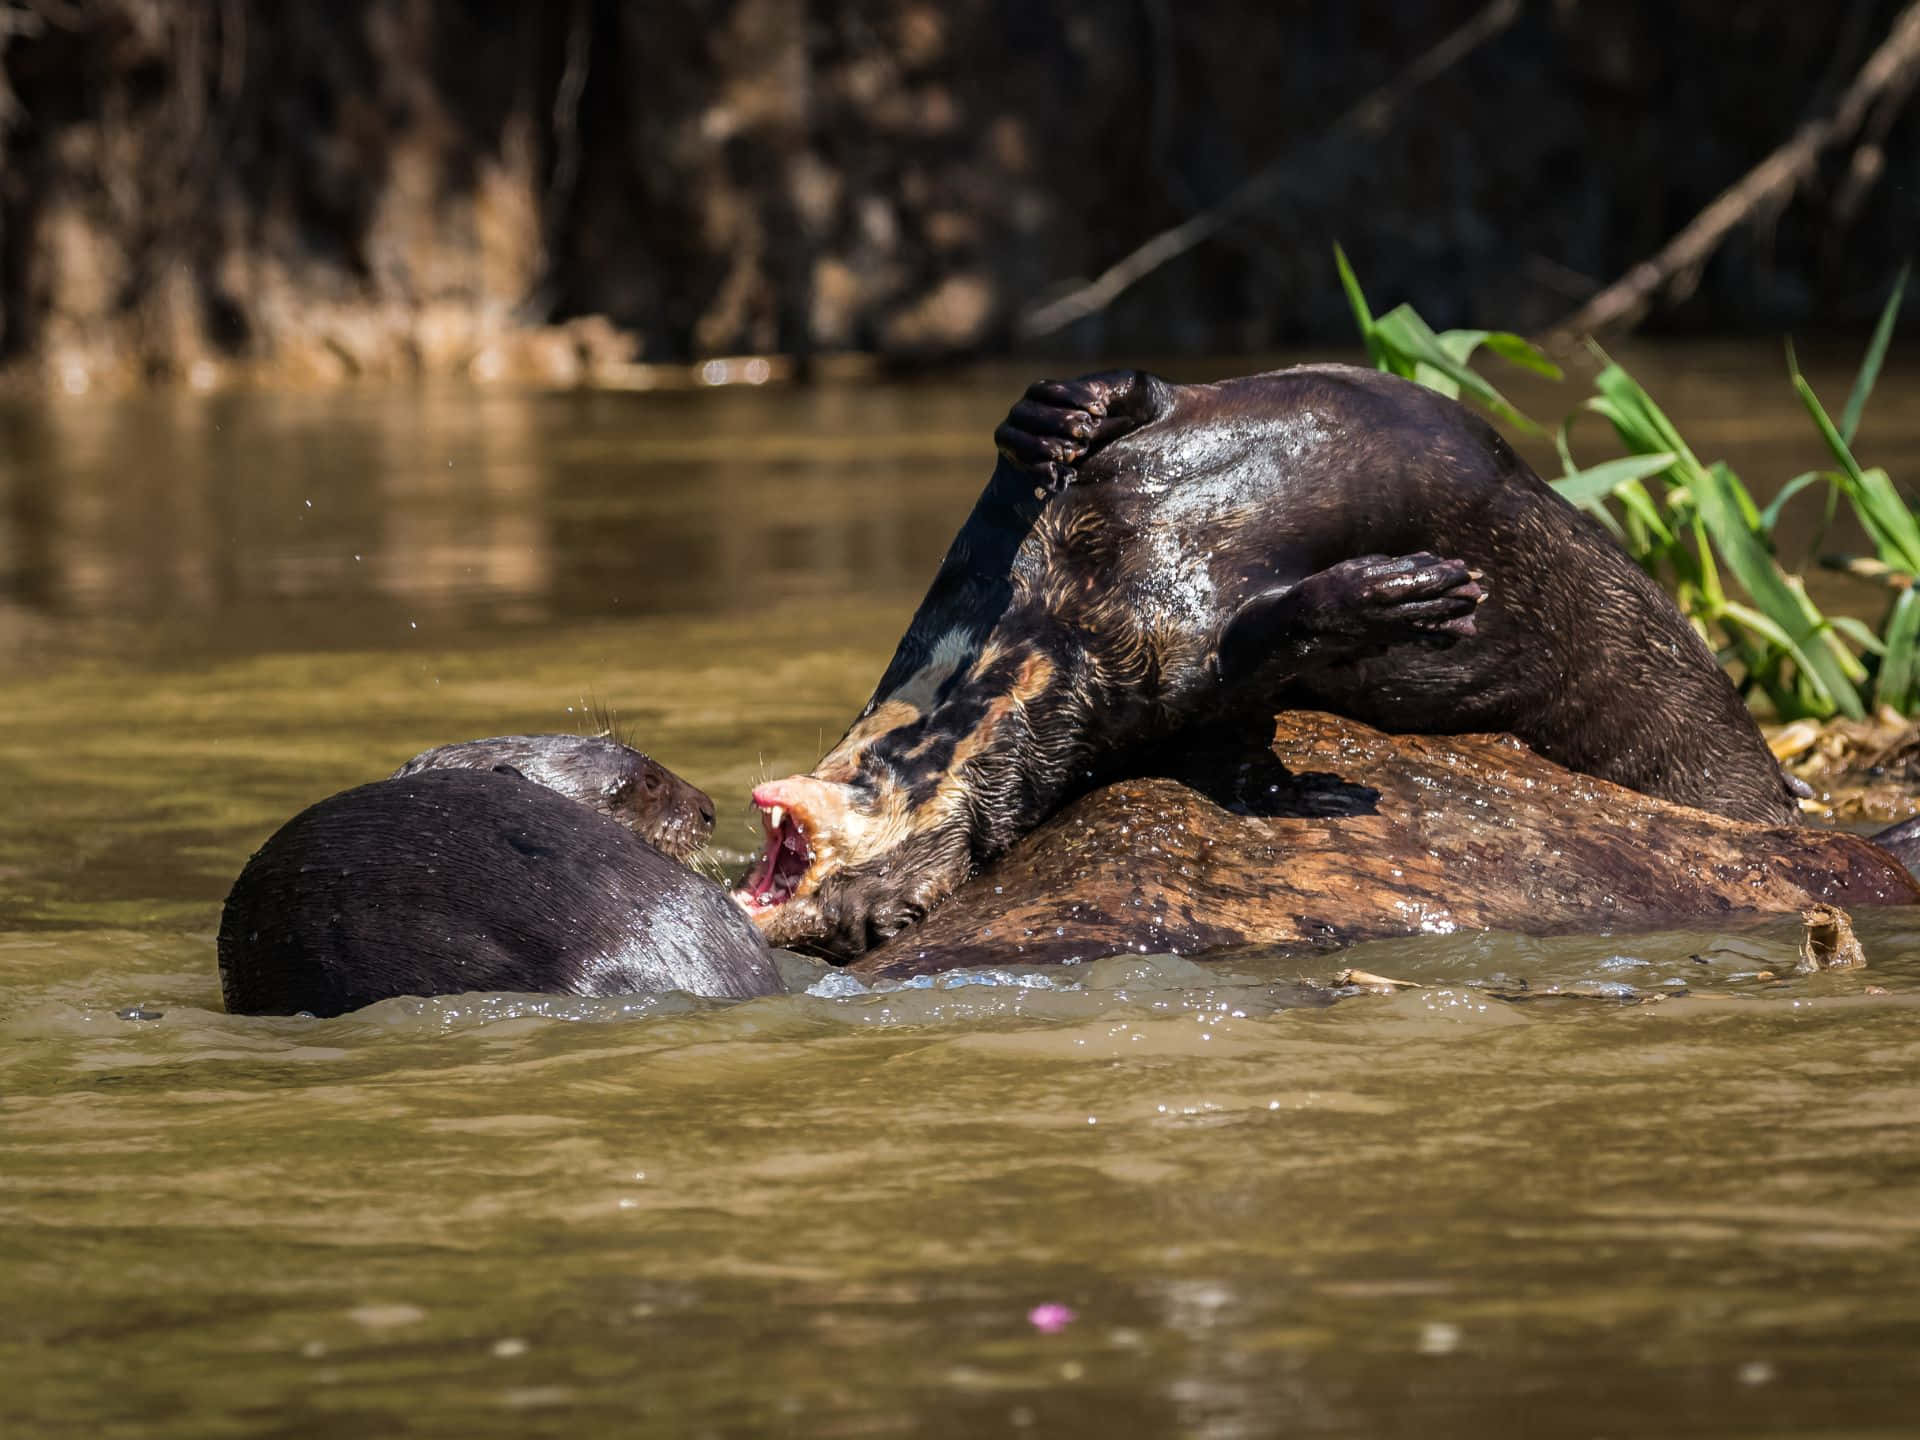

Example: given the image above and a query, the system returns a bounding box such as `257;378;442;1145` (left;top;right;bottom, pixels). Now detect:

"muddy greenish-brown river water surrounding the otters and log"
0;348;1920;1438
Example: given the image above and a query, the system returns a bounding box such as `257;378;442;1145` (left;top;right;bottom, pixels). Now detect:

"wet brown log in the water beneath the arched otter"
852;712;1920;981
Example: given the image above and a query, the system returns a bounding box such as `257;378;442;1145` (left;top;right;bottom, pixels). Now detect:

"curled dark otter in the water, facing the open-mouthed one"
219;735;783;1016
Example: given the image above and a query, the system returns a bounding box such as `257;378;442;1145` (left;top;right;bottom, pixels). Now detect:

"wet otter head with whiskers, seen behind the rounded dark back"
392;733;714;860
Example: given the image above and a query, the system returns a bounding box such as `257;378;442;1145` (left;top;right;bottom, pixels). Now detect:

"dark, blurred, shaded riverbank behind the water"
0;0;1920;388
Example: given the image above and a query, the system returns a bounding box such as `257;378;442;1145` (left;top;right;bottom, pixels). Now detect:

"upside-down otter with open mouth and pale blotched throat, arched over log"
735;365;1797;958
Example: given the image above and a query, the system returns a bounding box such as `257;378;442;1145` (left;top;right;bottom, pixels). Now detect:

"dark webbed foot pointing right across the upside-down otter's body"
1217;551;1486;684
